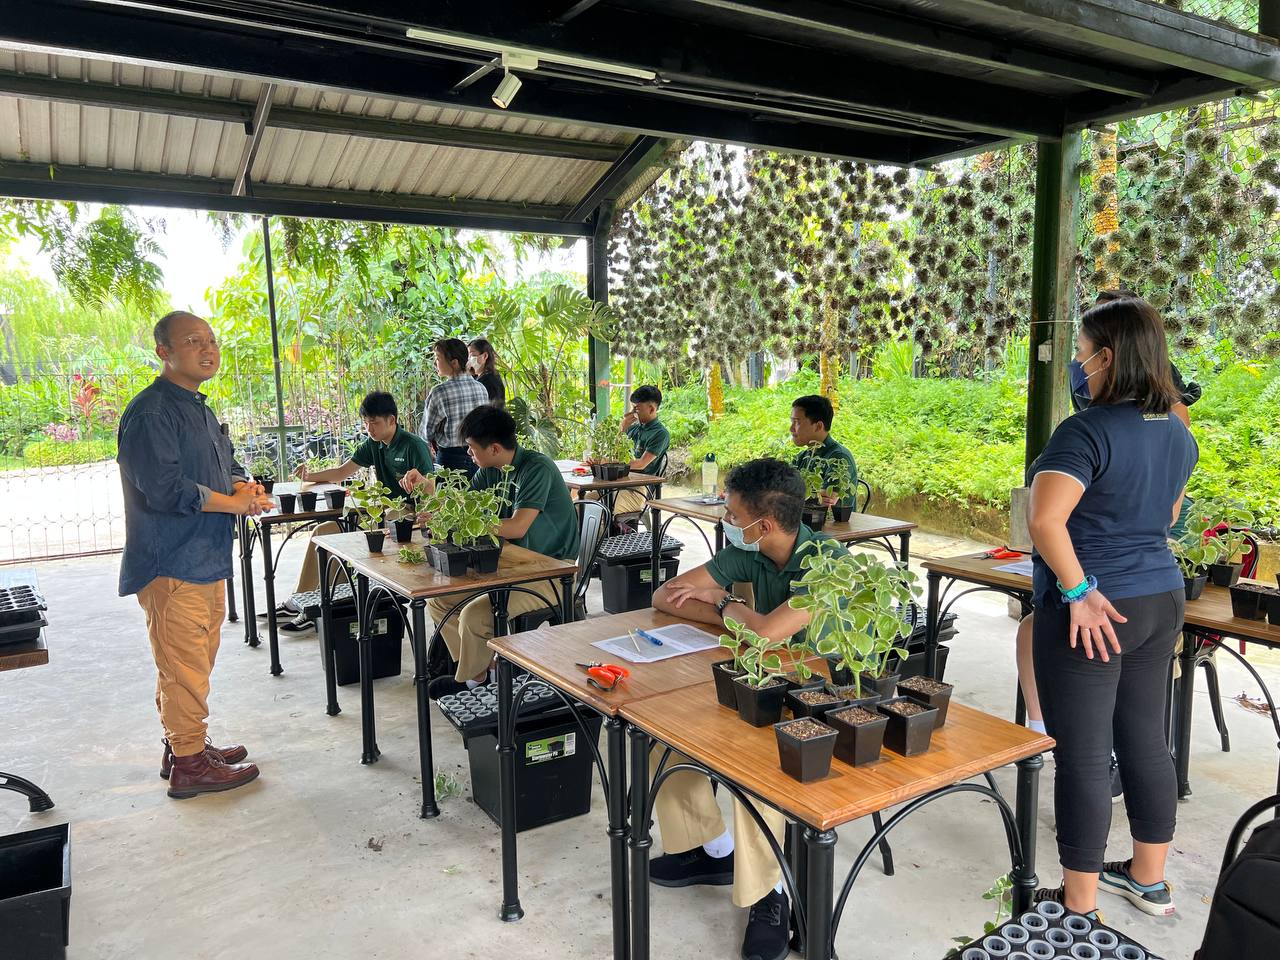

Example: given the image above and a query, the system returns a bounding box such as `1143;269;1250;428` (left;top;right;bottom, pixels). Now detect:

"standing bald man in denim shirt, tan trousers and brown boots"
118;311;273;799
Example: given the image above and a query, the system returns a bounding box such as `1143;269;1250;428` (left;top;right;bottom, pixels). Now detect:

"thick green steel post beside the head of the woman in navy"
1027;133;1082;466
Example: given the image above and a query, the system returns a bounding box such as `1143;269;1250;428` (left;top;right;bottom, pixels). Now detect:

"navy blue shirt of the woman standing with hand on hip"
1030;401;1199;605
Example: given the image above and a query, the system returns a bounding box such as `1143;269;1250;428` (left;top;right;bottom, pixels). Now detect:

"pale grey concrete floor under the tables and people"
0;519;1280;960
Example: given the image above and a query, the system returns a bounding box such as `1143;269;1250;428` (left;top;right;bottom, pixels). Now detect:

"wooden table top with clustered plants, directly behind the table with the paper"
312;532;577;600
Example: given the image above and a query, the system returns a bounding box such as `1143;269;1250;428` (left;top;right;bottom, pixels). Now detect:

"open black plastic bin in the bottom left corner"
0;823;72;960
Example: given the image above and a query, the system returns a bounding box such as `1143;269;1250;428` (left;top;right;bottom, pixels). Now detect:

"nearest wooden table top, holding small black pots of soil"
622;682;1053;831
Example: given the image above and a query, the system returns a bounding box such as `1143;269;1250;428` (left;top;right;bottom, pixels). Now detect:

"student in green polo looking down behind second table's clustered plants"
428;403;579;700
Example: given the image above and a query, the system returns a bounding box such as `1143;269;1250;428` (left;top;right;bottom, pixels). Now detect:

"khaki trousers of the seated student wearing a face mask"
649;749;786;906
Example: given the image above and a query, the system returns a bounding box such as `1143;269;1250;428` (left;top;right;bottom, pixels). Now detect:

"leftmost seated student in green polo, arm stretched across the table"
276;390;435;634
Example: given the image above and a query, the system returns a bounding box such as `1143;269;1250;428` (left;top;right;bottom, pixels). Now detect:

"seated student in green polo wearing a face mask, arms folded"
649;460;831;960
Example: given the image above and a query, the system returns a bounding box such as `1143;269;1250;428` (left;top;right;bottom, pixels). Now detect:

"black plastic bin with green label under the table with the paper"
467;708;600;831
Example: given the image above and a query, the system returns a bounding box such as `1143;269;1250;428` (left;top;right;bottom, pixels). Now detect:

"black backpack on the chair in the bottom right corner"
1196;794;1280;960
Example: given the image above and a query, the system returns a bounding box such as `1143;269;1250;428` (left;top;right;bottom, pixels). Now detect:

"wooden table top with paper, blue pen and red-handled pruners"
489;607;829;717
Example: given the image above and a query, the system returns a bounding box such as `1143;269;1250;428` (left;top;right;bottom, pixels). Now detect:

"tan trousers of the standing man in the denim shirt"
138;577;227;756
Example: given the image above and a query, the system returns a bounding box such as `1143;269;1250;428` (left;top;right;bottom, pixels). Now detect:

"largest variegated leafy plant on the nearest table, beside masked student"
791;540;919;695
